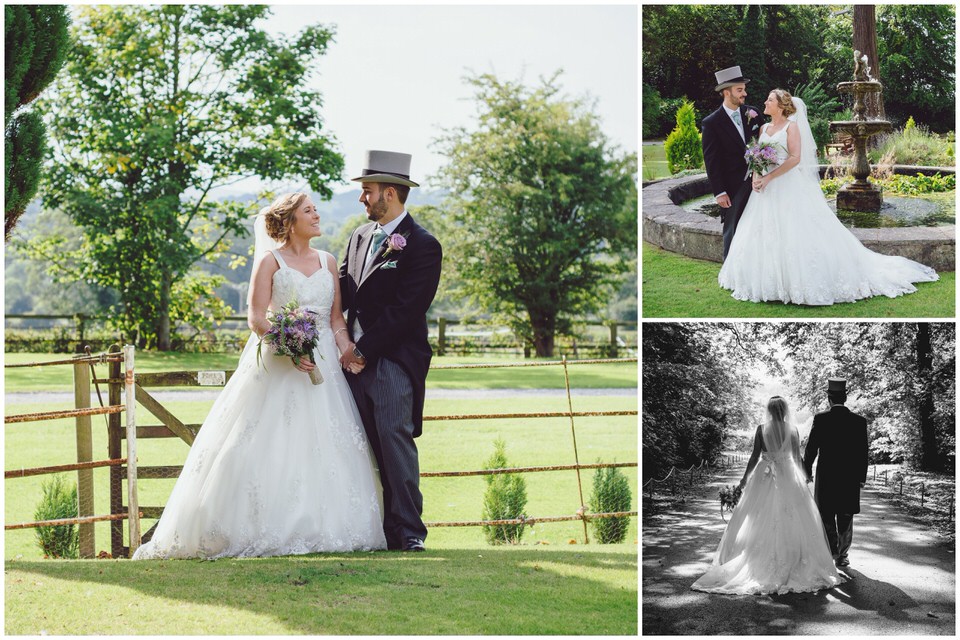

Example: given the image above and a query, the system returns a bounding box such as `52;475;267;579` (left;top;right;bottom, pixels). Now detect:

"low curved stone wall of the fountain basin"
640;166;956;271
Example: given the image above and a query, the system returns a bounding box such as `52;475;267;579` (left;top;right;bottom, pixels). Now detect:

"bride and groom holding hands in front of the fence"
134;151;442;559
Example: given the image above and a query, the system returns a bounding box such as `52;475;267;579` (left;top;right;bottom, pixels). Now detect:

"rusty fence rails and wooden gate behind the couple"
11;345;638;557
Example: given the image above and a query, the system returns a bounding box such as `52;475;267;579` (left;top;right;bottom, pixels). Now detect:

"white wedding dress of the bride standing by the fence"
134;252;386;560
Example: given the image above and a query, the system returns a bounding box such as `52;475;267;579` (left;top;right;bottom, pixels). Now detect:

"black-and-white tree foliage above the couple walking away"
642;323;956;477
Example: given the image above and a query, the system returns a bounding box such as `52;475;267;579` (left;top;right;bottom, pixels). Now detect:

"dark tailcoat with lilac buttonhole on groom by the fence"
340;213;443;437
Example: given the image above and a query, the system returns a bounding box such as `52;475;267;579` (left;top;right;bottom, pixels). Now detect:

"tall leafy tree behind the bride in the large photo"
35;5;343;349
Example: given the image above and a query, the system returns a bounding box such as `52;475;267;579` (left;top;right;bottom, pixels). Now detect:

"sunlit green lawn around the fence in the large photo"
4;353;639;635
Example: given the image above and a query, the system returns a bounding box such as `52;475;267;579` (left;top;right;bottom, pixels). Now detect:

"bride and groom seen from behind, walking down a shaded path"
693;378;867;594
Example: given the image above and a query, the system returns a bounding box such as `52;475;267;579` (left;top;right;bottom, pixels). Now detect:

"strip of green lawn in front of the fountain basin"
642;242;956;318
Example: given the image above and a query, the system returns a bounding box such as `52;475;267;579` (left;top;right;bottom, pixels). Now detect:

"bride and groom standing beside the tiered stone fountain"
702;67;938;305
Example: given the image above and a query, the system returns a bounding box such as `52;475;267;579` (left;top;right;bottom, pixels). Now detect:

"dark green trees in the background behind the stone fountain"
642;4;956;134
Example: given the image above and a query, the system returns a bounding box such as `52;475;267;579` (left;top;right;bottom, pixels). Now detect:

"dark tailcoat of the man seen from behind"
803;405;867;513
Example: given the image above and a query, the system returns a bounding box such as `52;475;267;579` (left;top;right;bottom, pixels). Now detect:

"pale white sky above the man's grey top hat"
240;4;639;191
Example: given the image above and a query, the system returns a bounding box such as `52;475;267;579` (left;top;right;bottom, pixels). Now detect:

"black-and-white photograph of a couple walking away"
641;322;956;636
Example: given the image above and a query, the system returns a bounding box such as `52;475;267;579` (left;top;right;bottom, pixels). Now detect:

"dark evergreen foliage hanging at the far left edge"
3;5;70;240
